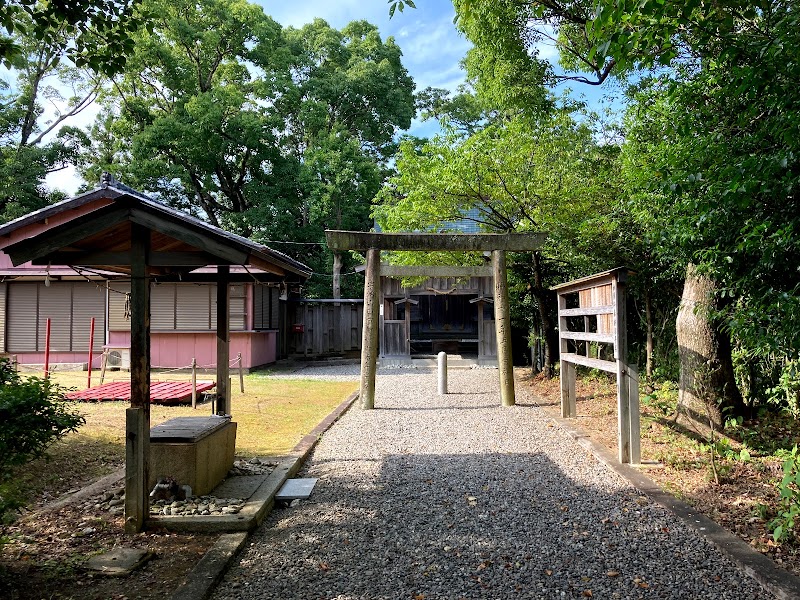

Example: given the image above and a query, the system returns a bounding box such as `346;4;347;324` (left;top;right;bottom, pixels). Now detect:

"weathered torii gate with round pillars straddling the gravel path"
325;230;545;409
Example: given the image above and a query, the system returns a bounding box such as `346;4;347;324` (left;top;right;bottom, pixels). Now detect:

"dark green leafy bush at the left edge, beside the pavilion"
0;359;85;518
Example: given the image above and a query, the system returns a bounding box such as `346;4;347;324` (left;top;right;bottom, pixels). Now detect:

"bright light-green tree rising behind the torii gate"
374;113;616;375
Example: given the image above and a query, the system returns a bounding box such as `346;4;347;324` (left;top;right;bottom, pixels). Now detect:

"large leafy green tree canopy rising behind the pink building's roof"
84;0;413;295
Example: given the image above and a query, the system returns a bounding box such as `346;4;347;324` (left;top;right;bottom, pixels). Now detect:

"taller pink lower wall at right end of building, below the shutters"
108;331;278;369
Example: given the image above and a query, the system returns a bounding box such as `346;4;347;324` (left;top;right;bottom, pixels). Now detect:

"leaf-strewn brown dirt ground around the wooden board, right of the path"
520;375;800;576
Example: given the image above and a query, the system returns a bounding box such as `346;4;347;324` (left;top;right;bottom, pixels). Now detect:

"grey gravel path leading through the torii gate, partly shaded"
214;369;771;600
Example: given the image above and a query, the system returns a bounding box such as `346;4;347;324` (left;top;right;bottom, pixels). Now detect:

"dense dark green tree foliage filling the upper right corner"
438;0;800;420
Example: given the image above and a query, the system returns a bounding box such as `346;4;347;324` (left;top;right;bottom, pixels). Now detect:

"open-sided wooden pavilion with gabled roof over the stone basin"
4;193;310;532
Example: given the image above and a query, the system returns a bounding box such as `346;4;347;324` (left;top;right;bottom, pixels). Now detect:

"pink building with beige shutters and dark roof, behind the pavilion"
0;180;311;368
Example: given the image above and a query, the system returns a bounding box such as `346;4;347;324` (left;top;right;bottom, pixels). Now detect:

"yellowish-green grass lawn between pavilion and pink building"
6;371;358;503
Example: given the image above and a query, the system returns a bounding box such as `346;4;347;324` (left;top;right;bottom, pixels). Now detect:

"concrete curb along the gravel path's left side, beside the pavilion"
171;391;358;600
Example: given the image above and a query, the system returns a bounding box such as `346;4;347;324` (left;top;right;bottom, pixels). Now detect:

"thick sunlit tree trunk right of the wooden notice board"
676;264;744;430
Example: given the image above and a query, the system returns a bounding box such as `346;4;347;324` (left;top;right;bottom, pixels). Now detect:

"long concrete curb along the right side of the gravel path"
548;415;800;600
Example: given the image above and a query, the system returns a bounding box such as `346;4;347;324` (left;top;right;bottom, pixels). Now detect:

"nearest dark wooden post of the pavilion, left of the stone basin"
125;223;150;533
